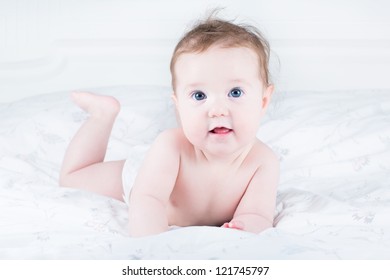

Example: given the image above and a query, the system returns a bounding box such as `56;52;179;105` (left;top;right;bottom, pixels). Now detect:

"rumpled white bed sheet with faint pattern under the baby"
0;86;390;259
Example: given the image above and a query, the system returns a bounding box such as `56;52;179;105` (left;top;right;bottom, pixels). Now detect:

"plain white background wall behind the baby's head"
0;0;390;102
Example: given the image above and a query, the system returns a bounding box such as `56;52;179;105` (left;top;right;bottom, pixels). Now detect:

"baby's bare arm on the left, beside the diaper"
129;130;179;237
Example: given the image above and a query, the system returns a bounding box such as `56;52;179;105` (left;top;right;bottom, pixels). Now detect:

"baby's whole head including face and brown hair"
171;15;273;156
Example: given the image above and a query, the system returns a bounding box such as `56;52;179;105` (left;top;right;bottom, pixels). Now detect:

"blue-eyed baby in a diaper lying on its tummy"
60;18;279;237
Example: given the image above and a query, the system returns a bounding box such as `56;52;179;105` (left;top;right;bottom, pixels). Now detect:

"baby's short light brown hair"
170;17;270;91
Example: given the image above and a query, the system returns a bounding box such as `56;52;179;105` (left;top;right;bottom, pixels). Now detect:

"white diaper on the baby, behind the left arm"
122;145;149;204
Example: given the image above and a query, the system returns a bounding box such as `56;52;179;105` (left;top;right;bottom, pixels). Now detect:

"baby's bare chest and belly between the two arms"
167;139;259;226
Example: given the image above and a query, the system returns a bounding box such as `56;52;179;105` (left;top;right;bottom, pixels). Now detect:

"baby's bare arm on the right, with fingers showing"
223;152;279;233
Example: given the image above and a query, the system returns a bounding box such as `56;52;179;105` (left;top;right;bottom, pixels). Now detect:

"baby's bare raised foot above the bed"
72;92;120;118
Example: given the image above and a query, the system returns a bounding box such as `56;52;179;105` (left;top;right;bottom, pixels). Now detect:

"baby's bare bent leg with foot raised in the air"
60;92;124;200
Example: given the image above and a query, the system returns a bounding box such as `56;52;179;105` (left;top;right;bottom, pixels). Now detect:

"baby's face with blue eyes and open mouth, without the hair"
173;46;273;155
